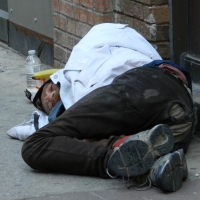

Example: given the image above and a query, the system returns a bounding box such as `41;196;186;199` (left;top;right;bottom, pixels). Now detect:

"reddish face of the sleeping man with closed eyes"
41;82;60;114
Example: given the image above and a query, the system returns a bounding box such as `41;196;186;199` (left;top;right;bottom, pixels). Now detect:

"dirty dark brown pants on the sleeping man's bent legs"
22;67;194;177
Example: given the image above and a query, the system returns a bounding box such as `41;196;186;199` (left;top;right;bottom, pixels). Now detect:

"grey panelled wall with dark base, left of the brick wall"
0;0;54;66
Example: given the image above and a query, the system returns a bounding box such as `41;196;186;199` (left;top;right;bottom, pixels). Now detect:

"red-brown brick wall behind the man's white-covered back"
52;0;170;68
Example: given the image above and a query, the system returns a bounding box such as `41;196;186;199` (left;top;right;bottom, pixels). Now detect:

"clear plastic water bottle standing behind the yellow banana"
25;50;41;87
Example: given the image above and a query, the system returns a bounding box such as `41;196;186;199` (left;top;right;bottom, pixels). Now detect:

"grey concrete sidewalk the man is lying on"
0;43;200;200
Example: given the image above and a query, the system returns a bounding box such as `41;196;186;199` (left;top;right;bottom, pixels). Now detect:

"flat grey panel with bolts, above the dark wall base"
8;0;53;38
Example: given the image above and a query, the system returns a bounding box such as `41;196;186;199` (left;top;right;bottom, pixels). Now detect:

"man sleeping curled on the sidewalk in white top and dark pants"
11;23;196;191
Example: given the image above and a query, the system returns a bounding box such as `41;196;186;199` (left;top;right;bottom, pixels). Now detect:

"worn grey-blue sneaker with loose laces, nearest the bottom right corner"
149;149;188;192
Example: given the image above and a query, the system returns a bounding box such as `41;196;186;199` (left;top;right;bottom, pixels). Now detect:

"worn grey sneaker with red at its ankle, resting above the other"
107;124;174;177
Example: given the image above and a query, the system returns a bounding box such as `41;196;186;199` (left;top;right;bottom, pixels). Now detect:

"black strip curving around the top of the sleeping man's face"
33;79;52;113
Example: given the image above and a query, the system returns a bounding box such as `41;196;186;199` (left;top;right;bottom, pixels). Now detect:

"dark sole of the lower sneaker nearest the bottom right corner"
155;151;188;192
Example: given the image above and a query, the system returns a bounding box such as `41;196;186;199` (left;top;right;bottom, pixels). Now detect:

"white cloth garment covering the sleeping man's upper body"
51;23;161;109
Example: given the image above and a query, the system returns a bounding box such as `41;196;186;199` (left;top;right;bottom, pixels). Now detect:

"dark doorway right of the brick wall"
171;0;200;84
